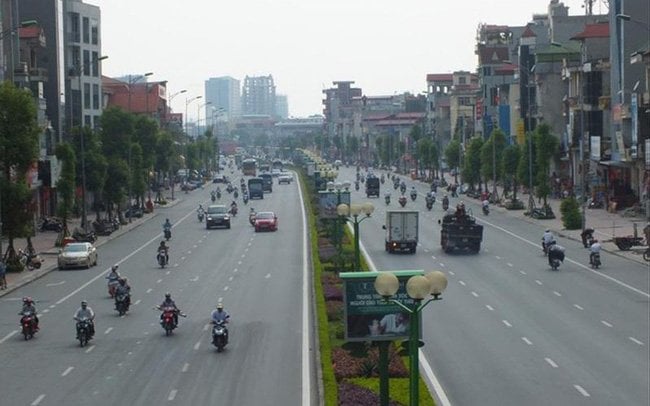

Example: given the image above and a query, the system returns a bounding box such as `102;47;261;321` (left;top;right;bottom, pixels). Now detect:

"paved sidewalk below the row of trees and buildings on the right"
428;178;650;268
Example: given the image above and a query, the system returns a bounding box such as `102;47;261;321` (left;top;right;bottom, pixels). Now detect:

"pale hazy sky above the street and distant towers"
90;0;596;120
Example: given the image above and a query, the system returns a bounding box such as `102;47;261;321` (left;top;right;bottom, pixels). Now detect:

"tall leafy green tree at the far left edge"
0;81;40;260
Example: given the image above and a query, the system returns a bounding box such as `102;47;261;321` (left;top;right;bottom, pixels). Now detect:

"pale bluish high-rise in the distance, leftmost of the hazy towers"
205;76;242;124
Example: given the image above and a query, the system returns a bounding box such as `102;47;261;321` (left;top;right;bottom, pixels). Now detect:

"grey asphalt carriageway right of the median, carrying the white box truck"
339;168;650;405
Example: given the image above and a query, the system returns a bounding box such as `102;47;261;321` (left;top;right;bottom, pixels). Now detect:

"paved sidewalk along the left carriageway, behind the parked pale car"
0;193;183;297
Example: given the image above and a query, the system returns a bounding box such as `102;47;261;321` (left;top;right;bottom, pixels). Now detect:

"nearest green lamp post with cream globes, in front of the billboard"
375;271;447;406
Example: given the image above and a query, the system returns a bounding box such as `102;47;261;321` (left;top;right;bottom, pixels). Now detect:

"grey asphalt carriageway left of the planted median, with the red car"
0;171;315;405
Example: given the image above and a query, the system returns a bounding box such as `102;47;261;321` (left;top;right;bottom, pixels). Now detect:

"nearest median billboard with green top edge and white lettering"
340;271;424;341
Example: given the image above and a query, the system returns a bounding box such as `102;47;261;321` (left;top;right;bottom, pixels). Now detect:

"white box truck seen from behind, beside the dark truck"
383;210;420;254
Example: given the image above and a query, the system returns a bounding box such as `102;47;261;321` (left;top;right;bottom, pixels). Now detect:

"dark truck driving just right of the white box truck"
438;214;483;253
